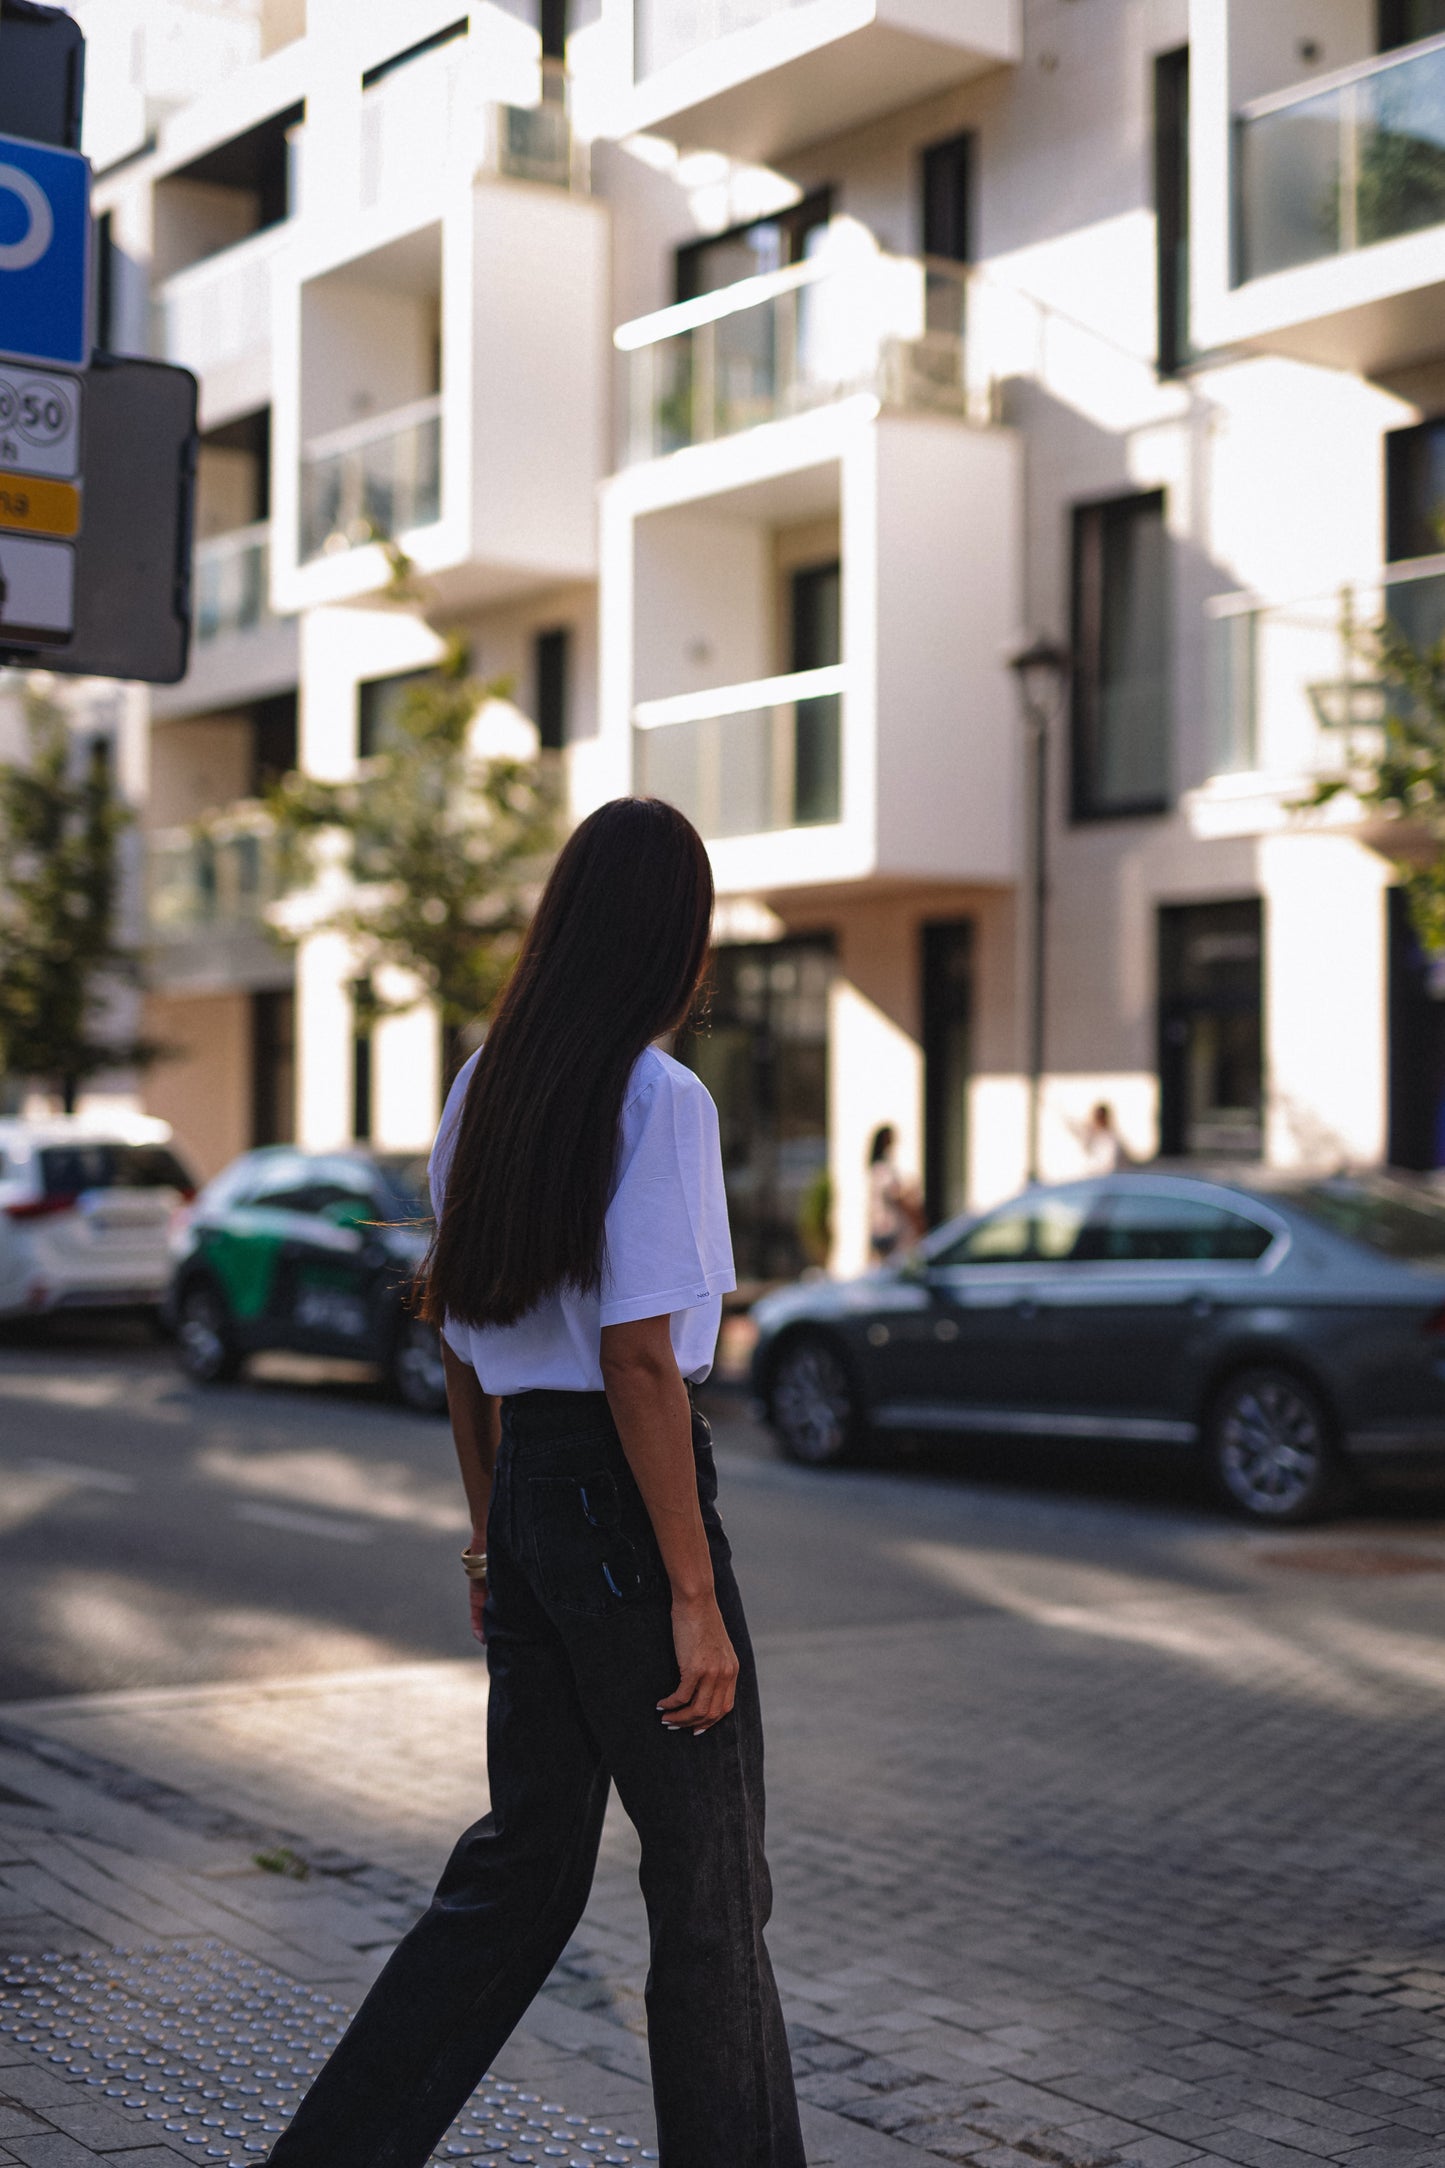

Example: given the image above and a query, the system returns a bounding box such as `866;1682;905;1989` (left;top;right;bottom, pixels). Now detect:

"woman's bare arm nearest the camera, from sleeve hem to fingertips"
602;1318;737;1734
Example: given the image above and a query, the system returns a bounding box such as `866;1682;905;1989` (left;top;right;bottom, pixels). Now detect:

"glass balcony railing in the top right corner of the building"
1239;37;1445;280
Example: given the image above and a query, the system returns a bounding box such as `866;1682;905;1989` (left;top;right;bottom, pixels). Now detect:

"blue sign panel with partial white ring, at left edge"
0;137;91;369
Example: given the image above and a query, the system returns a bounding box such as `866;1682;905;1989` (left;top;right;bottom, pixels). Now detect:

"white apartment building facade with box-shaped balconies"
70;0;1445;1281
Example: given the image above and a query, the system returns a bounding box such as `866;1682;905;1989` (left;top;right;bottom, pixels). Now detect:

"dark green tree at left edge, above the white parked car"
0;692;160;1114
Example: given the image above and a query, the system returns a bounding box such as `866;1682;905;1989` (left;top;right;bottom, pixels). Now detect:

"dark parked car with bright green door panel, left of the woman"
165;1145;446;1414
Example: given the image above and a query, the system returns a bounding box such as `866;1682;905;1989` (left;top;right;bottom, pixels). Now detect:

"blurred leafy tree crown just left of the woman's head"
266;640;559;1075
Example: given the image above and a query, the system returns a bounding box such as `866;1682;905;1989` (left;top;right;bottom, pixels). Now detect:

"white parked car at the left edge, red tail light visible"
0;1114;195;1316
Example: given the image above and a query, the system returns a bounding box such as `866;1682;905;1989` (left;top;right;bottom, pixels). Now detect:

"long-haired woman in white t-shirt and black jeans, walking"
261;798;804;2168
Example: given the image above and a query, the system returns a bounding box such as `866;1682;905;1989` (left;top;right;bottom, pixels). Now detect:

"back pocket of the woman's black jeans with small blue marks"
526;1468;665;1617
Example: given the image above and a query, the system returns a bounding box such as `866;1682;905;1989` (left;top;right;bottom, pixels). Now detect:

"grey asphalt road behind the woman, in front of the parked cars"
0;1322;1445;1702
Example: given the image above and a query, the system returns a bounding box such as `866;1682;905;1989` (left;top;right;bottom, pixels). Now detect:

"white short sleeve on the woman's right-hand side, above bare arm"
600;1056;737;1325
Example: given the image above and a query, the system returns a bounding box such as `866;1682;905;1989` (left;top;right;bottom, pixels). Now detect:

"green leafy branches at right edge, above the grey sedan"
1304;620;1445;956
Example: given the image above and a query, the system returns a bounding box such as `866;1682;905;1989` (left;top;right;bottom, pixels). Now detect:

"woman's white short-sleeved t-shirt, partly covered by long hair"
429;1047;737;1394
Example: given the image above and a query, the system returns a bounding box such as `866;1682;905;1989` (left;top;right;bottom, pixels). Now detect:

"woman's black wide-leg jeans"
261;1392;804;2168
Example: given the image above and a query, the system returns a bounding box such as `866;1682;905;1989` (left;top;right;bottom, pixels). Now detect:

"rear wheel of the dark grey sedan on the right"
1205;1364;1339;1526
